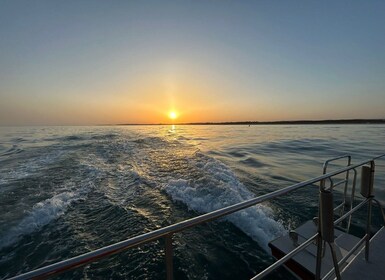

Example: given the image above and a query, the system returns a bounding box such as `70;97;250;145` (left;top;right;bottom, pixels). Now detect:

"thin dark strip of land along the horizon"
114;119;385;125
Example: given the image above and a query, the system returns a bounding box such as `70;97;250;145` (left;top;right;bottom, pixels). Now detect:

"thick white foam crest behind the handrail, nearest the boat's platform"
164;154;285;250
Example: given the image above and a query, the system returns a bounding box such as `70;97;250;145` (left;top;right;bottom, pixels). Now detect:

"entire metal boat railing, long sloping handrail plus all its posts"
11;154;385;279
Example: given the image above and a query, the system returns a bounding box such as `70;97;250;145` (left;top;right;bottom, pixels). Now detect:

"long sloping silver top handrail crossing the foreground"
10;154;385;280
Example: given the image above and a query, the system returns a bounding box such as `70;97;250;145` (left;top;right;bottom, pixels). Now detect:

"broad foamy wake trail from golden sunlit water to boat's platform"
132;138;285;251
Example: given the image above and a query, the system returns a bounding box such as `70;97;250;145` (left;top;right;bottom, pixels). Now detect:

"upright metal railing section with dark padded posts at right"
252;155;385;280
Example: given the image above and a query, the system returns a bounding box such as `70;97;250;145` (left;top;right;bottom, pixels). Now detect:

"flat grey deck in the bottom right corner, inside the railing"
341;227;385;280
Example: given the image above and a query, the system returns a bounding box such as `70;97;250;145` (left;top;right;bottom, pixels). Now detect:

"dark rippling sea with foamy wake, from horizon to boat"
0;125;385;279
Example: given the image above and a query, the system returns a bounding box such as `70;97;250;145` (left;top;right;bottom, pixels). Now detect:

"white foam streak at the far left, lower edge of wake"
0;188;87;249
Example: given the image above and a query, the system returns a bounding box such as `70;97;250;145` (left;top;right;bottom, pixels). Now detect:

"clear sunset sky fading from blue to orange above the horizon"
0;0;385;125
